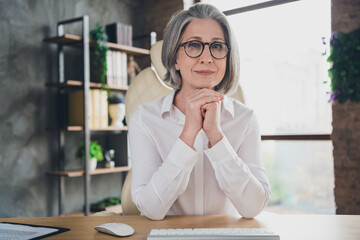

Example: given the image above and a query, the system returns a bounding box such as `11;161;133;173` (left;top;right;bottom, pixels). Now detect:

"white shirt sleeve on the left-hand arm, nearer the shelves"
129;108;199;220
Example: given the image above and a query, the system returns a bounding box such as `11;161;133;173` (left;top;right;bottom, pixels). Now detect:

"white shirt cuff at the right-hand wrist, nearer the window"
204;136;237;165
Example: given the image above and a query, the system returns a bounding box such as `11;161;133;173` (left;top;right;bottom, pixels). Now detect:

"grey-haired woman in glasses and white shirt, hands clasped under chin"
129;4;270;220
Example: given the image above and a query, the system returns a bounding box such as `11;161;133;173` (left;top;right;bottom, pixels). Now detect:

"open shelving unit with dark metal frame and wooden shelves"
43;16;150;216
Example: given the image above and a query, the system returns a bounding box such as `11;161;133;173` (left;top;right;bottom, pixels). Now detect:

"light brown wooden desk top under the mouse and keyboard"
0;213;360;240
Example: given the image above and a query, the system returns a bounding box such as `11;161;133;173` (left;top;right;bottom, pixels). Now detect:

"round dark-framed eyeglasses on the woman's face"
180;40;230;59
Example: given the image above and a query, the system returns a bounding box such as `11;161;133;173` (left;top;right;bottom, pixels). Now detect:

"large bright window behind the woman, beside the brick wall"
203;0;335;213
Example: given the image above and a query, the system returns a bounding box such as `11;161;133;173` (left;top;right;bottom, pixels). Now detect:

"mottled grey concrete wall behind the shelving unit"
0;0;145;217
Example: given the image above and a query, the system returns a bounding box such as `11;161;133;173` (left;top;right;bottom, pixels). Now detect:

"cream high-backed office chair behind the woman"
121;41;244;215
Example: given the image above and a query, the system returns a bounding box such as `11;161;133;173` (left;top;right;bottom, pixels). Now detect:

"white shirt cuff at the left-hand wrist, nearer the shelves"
167;138;200;171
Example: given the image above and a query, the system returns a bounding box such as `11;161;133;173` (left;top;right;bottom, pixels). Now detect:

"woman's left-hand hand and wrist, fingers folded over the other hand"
180;88;224;148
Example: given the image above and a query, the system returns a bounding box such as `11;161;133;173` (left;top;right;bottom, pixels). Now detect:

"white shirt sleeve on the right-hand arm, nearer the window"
205;112;271;218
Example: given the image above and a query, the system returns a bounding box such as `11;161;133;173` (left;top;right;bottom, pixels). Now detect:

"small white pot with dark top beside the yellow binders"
108;92;125;128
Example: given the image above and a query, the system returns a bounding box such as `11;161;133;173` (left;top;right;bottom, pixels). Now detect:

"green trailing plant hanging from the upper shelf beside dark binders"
90;23;109;89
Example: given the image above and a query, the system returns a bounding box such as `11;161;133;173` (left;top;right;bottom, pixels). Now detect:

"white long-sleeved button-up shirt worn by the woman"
129;92;271;220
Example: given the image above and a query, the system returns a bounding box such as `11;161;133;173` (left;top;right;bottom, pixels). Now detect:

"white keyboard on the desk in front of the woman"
147;228;280;240
